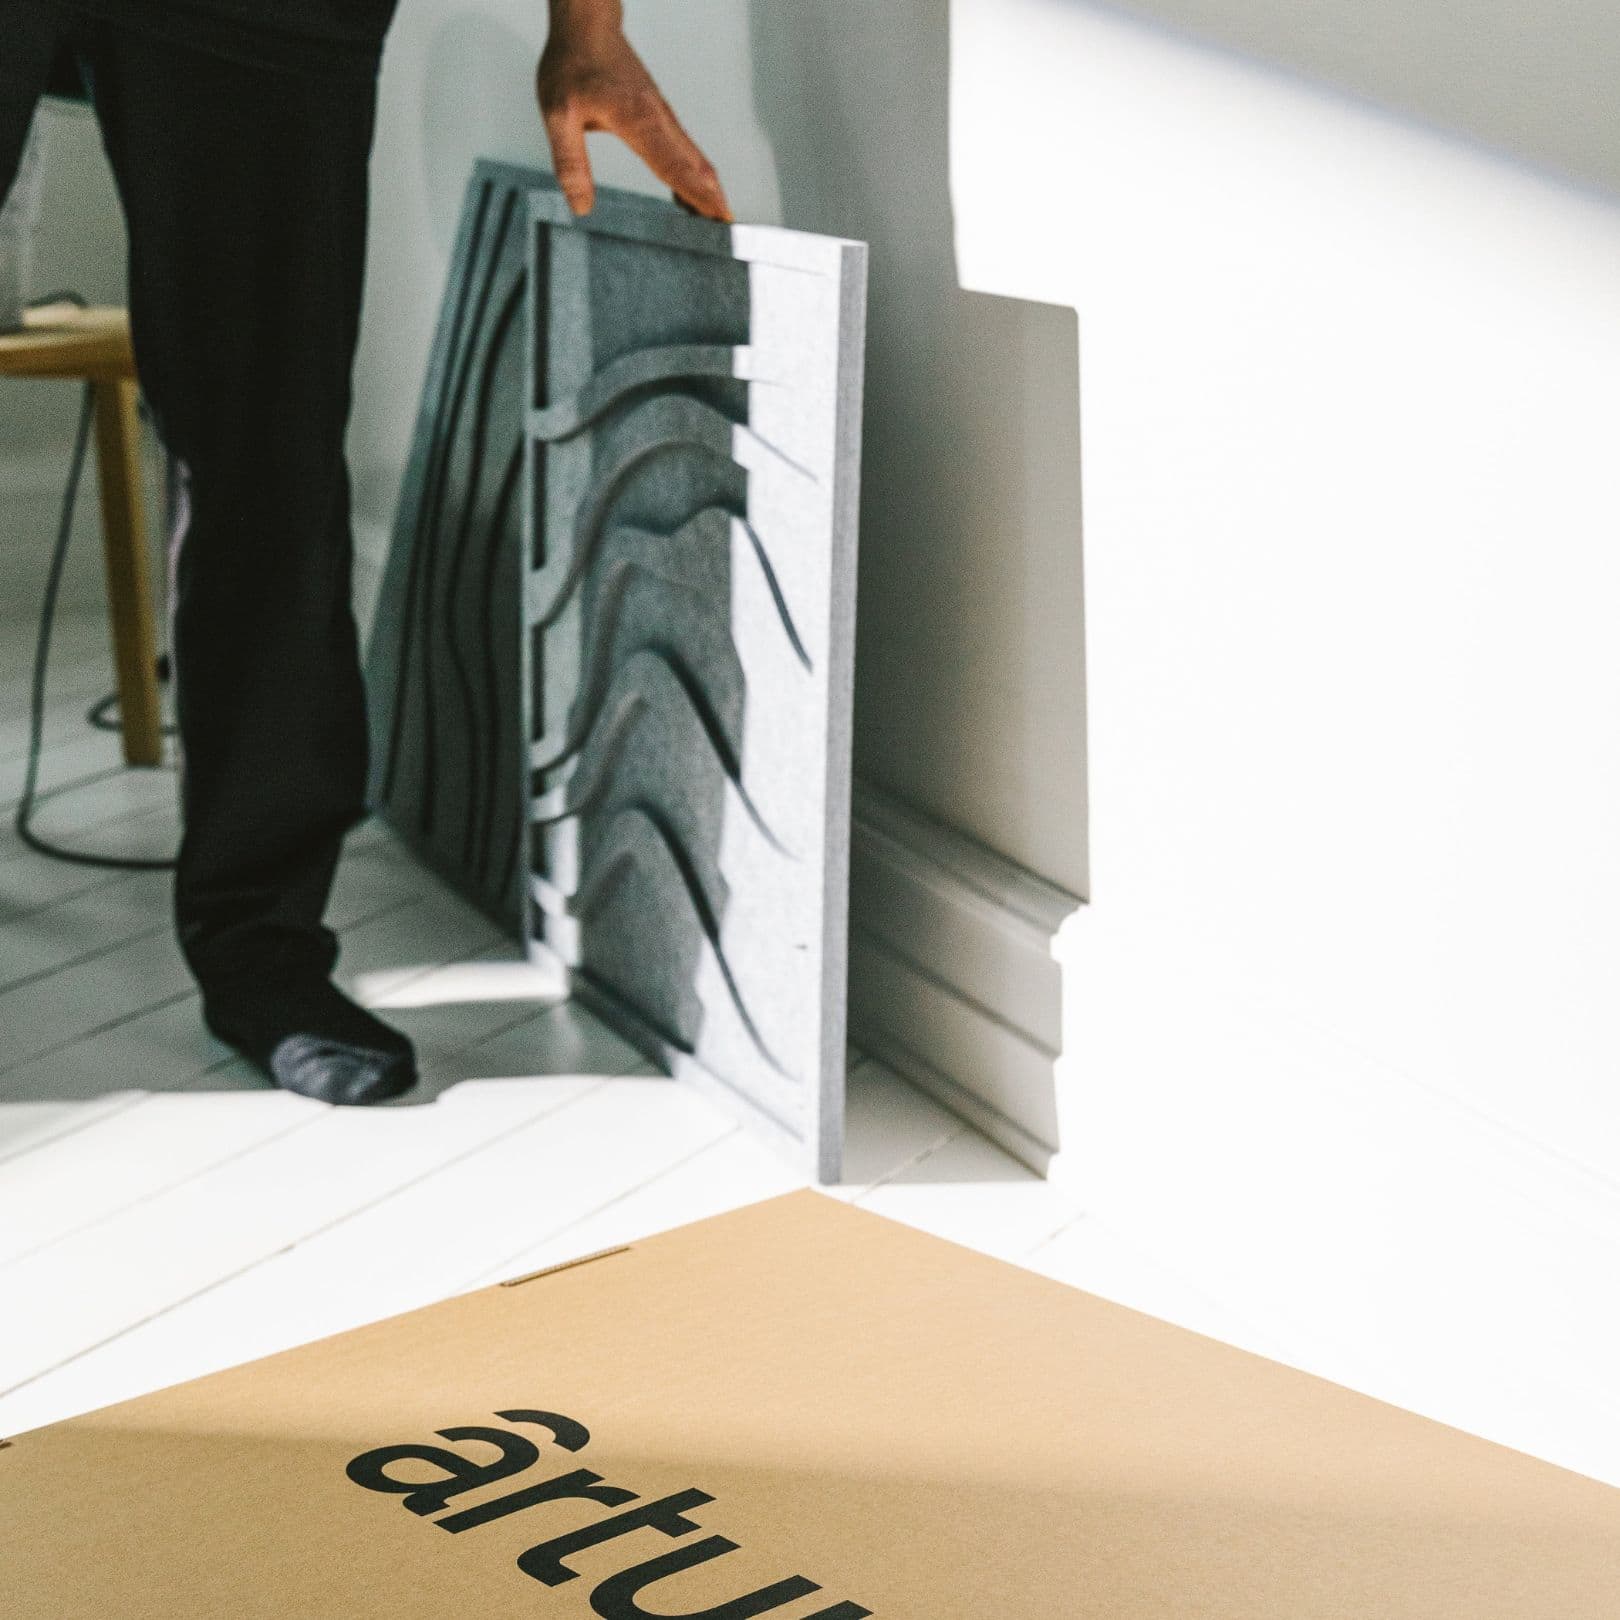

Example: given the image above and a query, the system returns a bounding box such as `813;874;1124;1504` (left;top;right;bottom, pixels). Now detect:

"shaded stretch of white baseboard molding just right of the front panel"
849;782;1081;1175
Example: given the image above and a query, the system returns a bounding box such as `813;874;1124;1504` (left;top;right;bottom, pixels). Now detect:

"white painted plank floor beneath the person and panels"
0;620;1268;1434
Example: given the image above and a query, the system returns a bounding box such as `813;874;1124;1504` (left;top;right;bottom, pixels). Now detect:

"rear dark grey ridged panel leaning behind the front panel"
366;162;549;936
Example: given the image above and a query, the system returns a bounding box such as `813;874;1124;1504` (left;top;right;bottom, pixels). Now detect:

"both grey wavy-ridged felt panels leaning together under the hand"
373;165;865;1178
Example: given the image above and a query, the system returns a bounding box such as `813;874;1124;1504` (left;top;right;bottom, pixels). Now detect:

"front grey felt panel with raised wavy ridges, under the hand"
520;188;865;1179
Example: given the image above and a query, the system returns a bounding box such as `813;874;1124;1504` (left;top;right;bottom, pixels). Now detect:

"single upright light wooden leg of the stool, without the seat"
96;377;164;765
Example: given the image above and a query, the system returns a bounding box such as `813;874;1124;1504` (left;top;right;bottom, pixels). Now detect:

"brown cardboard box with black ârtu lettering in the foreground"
9;1192;1620;1620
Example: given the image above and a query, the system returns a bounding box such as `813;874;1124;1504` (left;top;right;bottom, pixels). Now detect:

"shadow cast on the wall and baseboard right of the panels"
748;0;1090;1171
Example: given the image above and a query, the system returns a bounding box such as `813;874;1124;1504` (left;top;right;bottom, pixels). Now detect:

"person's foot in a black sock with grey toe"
203;977;416;1106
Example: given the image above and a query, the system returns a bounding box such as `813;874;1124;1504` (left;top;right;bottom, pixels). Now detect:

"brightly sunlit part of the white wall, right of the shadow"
954;0;1620;1477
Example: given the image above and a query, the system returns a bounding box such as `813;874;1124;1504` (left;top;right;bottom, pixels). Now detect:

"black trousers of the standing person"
0;0;381;988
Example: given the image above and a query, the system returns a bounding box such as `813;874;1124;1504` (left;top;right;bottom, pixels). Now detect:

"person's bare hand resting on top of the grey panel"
536;0;731;220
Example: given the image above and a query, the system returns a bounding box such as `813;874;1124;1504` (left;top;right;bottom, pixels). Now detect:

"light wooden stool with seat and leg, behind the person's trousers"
0;305;164;765
